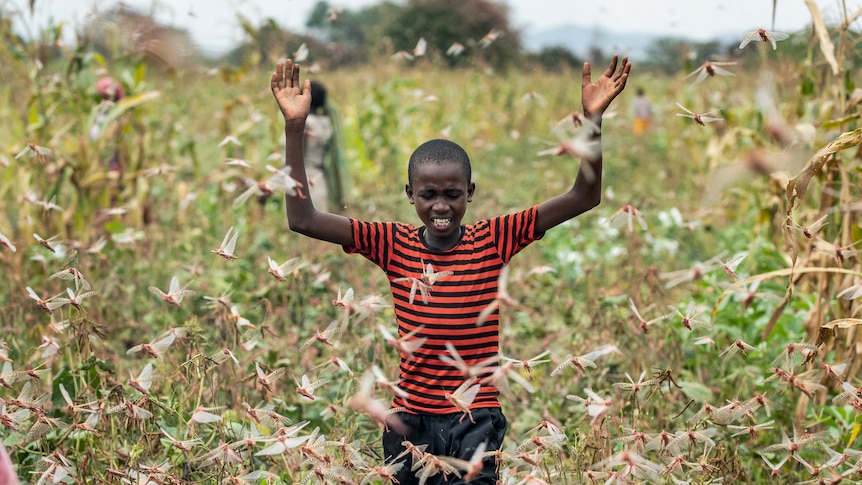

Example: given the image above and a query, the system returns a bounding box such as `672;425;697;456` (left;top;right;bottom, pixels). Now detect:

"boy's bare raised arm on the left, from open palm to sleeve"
270;59;353;245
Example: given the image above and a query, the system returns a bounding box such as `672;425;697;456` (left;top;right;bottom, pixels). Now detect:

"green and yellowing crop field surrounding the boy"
0;7;862;484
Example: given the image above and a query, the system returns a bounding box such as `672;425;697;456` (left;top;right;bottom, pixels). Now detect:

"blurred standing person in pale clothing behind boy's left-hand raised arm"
305;81;347;212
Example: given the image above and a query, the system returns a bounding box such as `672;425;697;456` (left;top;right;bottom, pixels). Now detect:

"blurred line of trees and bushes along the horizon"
0;0;832;73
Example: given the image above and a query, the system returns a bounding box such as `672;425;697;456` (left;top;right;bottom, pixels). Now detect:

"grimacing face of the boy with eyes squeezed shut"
405;162;476;242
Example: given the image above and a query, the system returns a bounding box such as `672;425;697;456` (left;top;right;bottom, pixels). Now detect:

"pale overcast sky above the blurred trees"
0;0;862;54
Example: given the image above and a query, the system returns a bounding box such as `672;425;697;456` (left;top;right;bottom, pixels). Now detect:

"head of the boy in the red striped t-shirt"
405;139;476;248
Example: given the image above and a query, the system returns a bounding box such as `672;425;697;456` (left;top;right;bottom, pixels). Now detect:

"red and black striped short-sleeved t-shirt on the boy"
344;207;542;414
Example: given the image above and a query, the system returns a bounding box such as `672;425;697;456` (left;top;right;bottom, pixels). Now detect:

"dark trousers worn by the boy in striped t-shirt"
383;408;507;485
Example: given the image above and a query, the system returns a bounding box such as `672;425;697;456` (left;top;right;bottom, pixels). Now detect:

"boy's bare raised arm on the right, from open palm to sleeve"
536;55;631;232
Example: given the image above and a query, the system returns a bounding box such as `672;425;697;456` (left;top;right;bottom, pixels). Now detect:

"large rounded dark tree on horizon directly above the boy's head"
383;0;521;67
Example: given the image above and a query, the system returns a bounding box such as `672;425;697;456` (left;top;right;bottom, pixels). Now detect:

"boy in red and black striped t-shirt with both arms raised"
270;55;631;485
